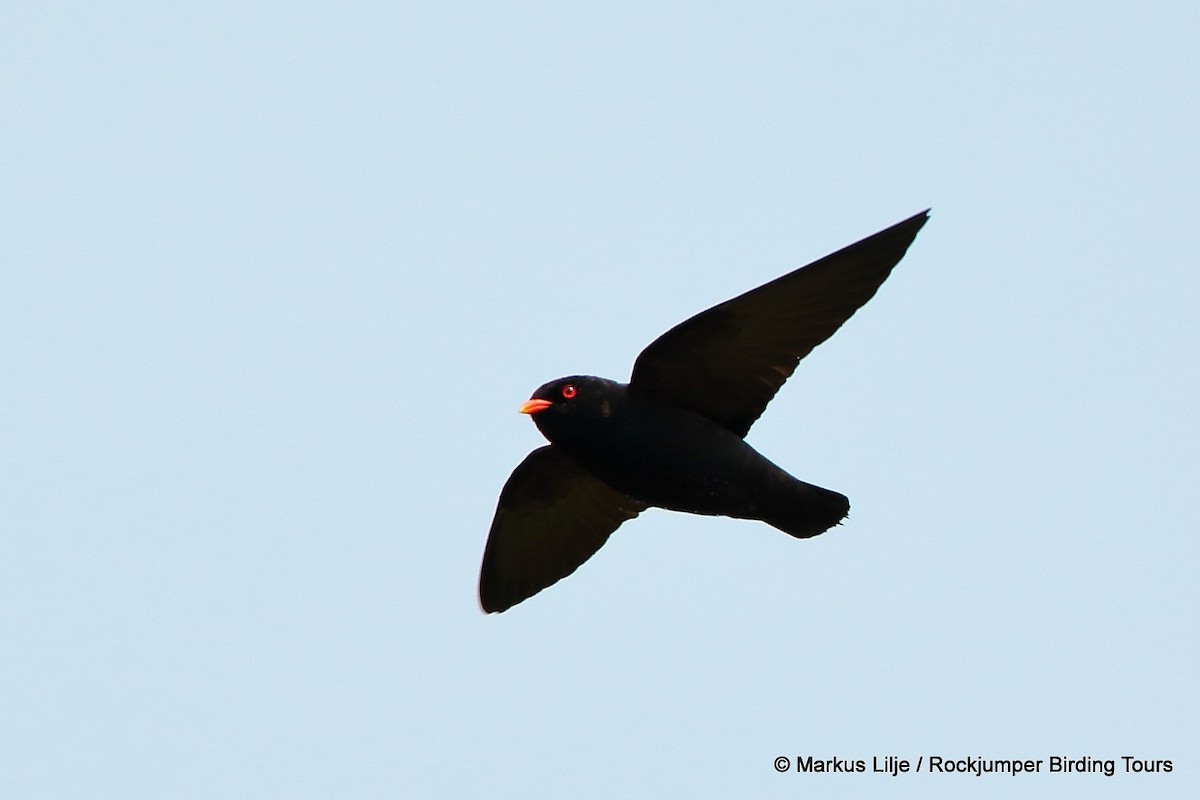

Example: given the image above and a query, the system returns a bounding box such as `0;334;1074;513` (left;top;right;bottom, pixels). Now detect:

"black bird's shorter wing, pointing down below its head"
479;445;646;613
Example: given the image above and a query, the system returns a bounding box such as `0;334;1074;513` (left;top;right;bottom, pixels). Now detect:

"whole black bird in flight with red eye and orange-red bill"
479;210;929;613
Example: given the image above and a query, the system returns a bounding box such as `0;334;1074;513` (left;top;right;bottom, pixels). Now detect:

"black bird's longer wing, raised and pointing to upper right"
629;211;929;437
